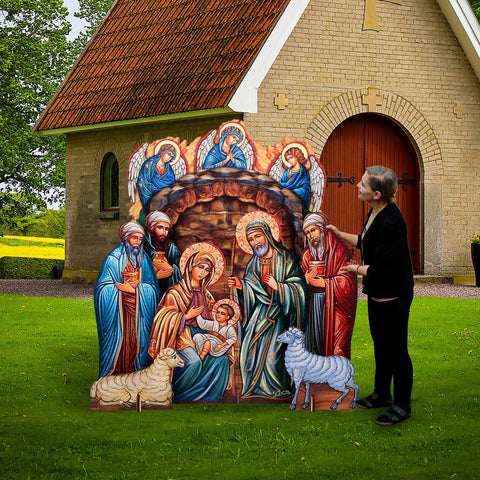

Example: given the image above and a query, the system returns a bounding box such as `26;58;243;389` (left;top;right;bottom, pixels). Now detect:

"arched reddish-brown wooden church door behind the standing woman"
321;114;422;273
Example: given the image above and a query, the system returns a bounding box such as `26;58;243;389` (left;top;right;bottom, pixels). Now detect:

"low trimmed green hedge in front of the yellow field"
0;257;65;279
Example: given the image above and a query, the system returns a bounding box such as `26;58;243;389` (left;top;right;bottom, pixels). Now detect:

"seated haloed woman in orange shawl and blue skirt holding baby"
148;243;230;401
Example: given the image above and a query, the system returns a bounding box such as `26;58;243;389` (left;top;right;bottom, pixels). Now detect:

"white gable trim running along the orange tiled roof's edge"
228;0;310;113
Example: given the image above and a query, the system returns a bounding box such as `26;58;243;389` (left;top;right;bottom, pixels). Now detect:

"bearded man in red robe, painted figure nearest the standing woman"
301;213;357;358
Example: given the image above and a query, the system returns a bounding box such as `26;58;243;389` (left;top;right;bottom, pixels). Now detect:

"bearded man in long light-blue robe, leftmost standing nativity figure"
94;222;160;377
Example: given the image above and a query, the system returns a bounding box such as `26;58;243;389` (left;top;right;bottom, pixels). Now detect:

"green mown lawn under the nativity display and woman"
0;295;480;480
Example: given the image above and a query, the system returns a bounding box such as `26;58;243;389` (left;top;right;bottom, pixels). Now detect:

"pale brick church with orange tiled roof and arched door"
34;0;480;283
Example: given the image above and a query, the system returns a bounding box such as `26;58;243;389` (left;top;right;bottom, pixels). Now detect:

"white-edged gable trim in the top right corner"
437;0;480;80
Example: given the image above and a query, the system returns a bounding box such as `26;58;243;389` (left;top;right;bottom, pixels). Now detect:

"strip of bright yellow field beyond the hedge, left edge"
0;235;65;260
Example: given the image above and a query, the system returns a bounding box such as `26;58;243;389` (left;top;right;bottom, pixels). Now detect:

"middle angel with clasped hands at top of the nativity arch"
197;120;255;170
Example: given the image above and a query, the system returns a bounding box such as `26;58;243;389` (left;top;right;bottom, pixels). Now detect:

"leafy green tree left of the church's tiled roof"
0;0;72;208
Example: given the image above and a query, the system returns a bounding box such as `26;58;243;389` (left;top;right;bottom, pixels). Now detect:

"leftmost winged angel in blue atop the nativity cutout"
128;138;187;214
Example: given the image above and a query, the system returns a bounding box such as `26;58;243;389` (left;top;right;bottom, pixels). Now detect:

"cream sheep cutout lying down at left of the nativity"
90;347;185;409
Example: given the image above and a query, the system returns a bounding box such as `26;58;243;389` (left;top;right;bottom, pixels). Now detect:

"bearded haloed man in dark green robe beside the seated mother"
227;218;307;399
